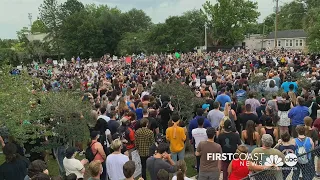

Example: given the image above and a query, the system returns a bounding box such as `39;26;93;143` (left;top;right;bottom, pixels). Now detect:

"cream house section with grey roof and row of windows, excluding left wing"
264;29;307;50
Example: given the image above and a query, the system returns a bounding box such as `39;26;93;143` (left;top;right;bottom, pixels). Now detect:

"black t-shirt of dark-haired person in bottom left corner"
0;157;29;180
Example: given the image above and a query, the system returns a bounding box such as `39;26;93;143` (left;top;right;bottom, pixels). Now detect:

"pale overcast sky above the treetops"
0;0;293;39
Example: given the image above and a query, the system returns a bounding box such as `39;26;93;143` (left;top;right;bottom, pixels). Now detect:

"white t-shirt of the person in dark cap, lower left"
63;158;84;179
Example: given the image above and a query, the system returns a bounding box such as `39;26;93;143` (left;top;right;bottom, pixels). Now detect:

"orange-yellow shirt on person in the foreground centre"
166;124;187;153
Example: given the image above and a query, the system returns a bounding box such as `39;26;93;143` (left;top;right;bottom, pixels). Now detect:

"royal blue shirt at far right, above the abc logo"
288;106;309;126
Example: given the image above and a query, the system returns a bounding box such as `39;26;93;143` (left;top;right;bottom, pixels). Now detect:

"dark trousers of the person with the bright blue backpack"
292;158;315;180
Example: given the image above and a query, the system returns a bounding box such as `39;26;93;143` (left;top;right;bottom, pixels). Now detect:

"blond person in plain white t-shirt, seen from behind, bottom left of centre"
106;139;129;180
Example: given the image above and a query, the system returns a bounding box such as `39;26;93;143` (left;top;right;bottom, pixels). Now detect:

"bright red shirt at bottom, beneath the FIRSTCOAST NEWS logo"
229;159;249;180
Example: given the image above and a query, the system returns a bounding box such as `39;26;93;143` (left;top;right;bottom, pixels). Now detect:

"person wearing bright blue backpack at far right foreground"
292;125;315;180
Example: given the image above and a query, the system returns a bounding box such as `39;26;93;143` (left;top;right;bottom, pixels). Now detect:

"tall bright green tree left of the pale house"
203;0;260;45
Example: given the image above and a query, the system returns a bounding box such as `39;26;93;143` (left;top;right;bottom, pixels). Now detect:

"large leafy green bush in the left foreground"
0;66;91;151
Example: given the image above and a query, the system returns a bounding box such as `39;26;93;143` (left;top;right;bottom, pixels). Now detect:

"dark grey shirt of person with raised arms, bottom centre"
147;157;177;180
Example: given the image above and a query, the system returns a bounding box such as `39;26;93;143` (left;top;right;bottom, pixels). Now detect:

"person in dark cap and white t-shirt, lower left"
63;147;88;179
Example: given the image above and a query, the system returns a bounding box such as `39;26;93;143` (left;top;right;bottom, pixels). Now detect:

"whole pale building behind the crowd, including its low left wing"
243;29;307;50
